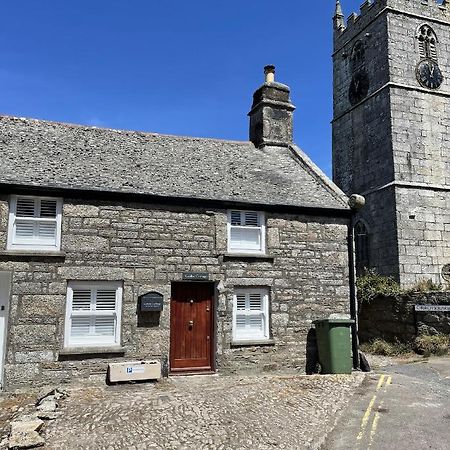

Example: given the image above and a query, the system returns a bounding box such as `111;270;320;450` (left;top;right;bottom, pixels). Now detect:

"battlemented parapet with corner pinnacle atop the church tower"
333;0;450;50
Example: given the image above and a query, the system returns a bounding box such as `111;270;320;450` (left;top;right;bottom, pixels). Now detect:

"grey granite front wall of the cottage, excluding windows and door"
0;196;349;389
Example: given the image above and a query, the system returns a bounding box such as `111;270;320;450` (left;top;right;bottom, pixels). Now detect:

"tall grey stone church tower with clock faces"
333;0;450;286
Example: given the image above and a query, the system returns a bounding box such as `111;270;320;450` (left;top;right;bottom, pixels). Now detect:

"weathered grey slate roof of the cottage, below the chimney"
0;116;348;210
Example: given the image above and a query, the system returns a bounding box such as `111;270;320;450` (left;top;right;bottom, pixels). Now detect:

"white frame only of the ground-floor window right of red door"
232;287;270;343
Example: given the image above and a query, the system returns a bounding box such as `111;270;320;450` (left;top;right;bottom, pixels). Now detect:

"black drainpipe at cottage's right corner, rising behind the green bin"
348;194;366;369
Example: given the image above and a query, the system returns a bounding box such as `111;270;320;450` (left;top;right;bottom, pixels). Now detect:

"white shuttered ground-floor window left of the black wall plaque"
64;281;123;347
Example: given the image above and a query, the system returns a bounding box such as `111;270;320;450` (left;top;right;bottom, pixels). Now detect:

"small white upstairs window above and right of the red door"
228;210;266;253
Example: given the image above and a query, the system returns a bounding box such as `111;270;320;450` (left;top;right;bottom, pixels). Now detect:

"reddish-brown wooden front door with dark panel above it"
170;283;214;372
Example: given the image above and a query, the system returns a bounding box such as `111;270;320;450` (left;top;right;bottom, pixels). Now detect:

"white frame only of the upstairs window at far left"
6;195;63;251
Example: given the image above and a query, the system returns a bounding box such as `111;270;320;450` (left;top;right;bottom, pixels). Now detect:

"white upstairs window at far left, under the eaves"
7;196;62;250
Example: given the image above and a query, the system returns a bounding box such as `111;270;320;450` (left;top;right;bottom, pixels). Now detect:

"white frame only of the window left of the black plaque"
64;281;123;349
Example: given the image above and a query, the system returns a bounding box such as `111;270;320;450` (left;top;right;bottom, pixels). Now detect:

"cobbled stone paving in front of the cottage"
34;373;364;450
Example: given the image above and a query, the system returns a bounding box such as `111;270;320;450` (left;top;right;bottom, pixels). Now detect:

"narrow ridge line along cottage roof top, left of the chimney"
0;114;253;146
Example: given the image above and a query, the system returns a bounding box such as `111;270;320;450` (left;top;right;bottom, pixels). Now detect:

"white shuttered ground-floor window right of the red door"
233;288;269;341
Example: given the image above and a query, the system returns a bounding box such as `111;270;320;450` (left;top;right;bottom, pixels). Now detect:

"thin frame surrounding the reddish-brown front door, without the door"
168;280;218;376
